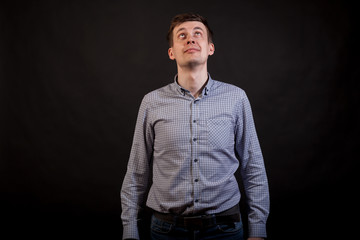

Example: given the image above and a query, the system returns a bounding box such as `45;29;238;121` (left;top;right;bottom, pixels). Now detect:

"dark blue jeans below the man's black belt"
151;216;244;240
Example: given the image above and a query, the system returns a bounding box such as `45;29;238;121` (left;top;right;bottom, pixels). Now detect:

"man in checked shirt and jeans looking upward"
121;14;269;240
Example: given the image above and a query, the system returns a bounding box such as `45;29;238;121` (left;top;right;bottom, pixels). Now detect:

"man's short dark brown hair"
166;13;213;47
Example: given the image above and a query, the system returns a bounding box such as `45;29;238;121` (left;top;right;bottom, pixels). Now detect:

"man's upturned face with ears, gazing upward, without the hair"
168;21;215;67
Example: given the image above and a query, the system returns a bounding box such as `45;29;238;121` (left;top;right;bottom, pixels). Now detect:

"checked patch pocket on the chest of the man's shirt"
207;118;235;149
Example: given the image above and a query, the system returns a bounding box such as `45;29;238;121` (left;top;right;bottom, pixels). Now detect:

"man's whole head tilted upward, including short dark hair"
168;14;215;68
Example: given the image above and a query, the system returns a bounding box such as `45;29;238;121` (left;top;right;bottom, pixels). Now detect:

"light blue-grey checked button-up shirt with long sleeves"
121;75;269;239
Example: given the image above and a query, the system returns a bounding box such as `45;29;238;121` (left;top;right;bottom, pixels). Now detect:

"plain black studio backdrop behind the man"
0;0;359;240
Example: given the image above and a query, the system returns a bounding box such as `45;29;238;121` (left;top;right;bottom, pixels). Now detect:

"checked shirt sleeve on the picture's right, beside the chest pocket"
236;92;270;237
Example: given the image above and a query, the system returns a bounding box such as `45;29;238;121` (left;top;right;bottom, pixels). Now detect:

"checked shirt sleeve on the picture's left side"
120;98;154;239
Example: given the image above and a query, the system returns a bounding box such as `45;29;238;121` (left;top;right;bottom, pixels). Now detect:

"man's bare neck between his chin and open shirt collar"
178;65;208;98
